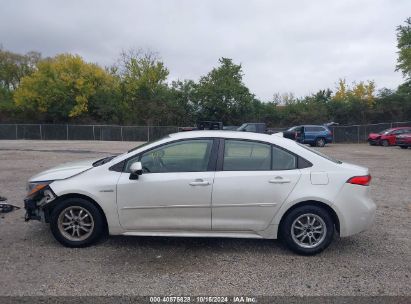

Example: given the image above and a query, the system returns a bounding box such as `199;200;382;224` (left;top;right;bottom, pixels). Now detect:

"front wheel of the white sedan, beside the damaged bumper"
50;197;105;248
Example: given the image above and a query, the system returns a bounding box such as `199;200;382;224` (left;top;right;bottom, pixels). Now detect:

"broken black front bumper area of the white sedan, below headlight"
24;186;57;223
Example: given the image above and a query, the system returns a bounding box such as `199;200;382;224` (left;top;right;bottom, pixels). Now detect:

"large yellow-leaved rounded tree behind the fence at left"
14;54;116;122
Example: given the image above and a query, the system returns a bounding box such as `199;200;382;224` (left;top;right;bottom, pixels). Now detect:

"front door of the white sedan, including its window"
117;139;216;231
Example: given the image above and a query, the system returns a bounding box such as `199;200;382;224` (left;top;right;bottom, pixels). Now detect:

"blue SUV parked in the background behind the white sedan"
283;125;333;147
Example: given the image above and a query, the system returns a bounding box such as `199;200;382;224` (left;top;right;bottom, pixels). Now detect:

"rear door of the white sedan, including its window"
212;139;300;231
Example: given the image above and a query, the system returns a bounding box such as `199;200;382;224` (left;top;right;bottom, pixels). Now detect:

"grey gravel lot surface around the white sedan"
0;141;411;295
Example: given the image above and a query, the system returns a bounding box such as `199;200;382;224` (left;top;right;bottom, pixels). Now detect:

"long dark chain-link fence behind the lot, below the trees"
0;121;411;143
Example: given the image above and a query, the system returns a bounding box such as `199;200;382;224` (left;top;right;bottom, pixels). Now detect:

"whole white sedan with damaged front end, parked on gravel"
25;131;376;254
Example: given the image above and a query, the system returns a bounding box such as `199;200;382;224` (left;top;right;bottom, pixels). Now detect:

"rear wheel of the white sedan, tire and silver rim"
279;205;335;255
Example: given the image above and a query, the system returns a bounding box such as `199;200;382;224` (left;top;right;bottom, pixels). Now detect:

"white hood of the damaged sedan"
29;158;99;182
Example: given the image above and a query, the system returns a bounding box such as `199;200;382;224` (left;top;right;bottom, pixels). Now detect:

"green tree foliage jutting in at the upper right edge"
396;17;411;79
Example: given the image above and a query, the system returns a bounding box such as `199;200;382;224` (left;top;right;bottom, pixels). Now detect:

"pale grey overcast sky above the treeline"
0;0;411;100
